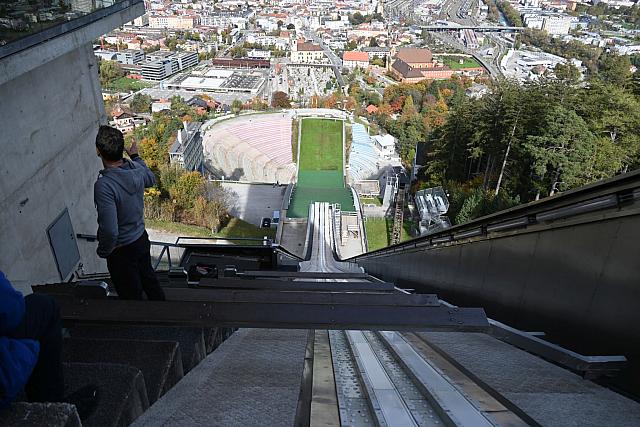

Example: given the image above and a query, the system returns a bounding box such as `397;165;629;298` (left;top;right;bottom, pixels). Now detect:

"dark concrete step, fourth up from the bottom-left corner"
69;324;207;374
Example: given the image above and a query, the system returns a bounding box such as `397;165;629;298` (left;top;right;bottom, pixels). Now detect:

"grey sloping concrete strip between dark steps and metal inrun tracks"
133;329;307;427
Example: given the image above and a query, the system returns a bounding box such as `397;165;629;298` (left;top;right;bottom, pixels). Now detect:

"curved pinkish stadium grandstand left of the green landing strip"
202;113;296;184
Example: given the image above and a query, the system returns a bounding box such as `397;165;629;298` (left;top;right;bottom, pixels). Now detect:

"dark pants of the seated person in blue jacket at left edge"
10;294;64;402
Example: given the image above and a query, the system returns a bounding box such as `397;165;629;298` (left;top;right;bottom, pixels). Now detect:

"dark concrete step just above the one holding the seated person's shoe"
62;338;184;404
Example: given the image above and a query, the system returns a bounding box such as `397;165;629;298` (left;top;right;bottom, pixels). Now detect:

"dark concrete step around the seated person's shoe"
64;363;149;427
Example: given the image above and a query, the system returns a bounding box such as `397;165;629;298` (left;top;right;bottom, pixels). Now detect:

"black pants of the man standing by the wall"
107;231;165;301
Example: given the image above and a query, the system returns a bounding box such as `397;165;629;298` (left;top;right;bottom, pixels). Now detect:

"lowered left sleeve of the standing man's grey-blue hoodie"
93;178;118;258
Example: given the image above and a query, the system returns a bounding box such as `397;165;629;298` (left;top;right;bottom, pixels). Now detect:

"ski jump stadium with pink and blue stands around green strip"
203;109;399;214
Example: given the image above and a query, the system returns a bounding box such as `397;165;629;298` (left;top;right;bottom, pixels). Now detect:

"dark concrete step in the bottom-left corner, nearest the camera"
0;402;82;427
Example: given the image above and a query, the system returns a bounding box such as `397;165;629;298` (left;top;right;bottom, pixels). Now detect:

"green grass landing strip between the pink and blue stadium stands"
287;119;355;218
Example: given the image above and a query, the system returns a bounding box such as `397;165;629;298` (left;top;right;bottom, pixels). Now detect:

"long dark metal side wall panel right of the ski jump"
358;214;640;353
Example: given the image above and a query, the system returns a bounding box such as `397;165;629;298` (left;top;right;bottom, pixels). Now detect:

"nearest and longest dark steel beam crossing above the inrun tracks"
42;294;488;331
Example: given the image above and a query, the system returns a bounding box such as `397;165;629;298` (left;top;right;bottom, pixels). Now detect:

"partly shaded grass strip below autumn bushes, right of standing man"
144;218;276;239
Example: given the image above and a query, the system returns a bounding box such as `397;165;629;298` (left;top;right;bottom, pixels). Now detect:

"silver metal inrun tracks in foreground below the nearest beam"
296;330;536;427
